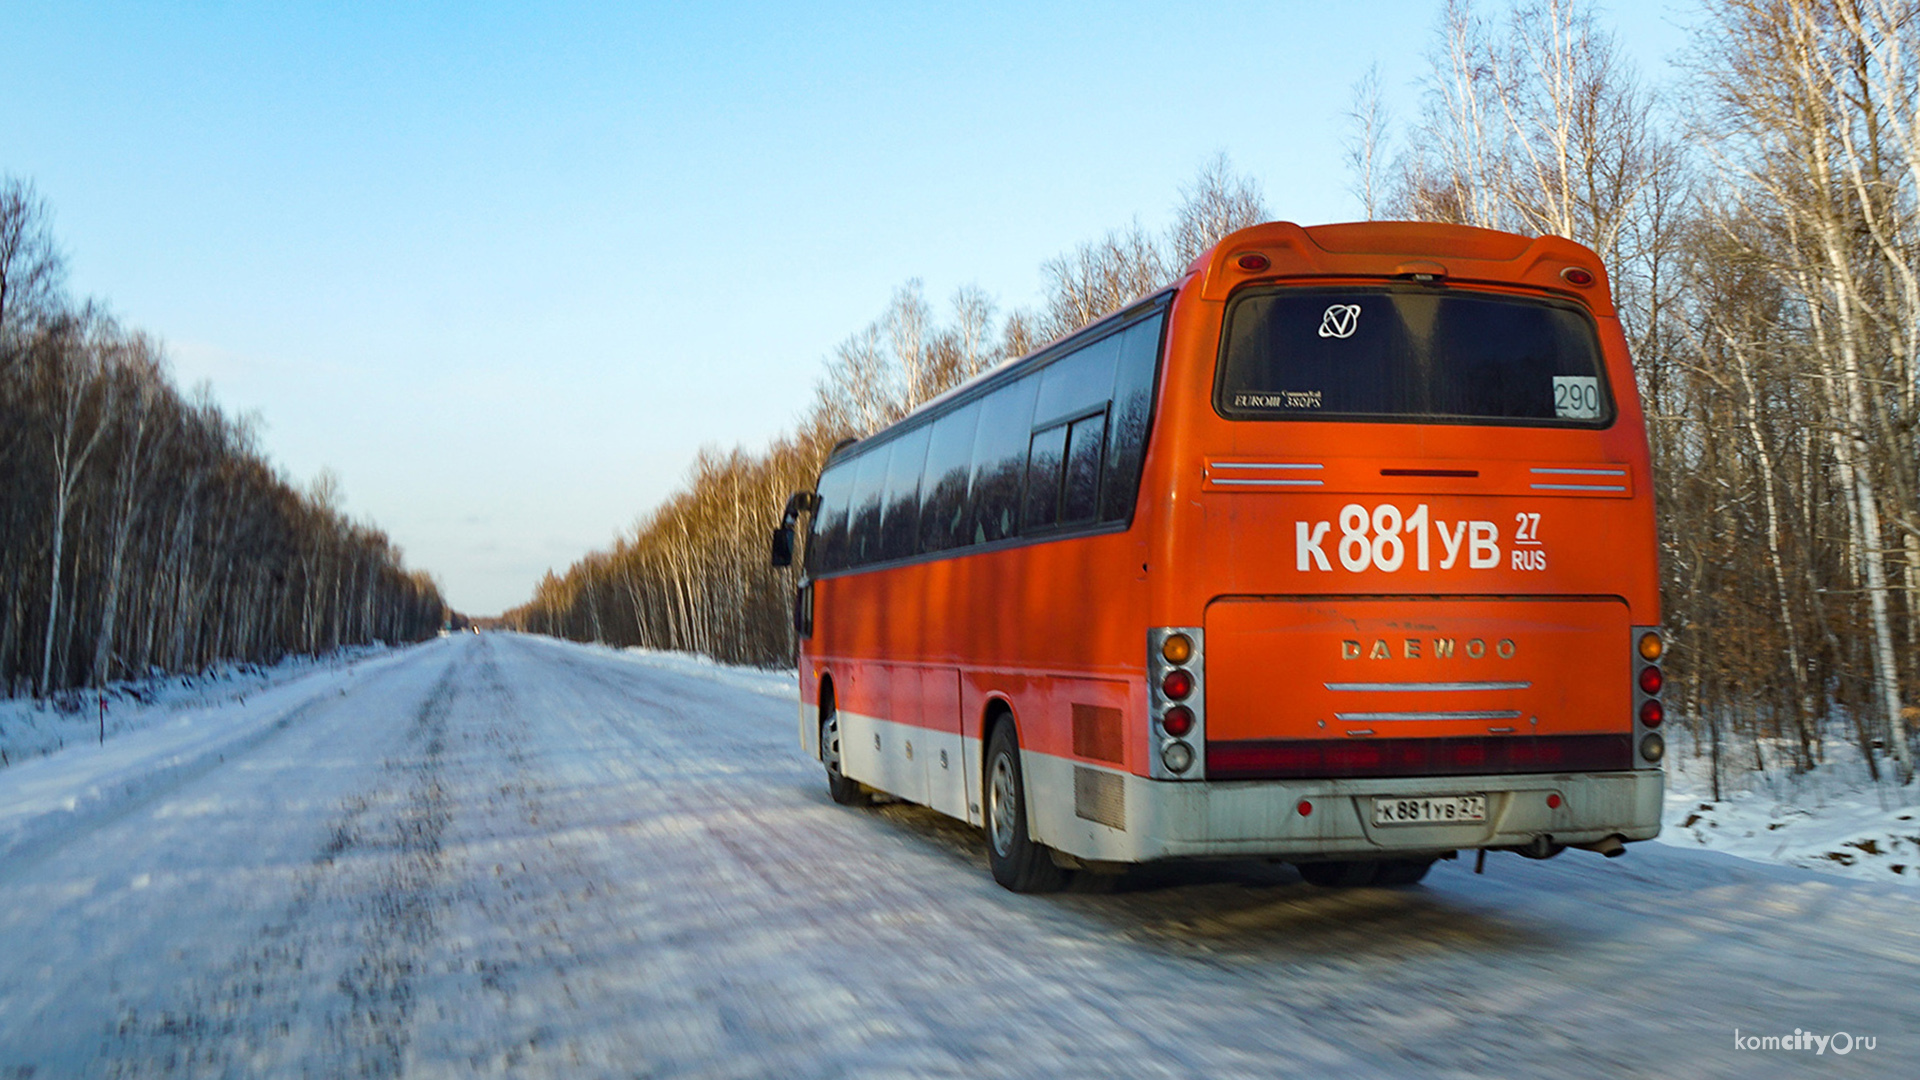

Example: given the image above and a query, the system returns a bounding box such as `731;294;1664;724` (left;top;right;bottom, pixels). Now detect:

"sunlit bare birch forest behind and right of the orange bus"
506;0;1920;798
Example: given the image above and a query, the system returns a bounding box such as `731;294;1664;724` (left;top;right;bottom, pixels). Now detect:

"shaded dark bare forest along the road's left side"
0;177;445;700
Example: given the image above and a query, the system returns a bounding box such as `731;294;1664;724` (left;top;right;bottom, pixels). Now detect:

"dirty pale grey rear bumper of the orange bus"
1027;755;1667;863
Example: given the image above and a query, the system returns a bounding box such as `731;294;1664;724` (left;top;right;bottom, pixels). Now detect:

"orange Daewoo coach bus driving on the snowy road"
774;223;1665;892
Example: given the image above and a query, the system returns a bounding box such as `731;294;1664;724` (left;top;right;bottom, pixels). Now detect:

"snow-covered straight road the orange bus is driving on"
0;636;1920;1080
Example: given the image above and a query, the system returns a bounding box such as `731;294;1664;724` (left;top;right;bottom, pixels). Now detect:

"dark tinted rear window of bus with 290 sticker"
1213;286;1613;427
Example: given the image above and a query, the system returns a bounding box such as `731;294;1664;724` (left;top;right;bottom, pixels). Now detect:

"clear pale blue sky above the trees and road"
0;0;1684;613
